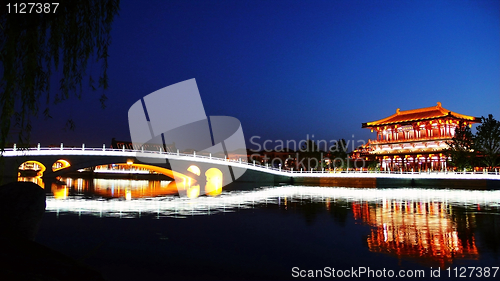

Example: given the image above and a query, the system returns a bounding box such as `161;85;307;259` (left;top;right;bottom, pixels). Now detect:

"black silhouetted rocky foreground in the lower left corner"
0;182;103;280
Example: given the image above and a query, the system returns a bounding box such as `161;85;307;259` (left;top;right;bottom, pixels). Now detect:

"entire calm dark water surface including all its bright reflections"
29;178;500;280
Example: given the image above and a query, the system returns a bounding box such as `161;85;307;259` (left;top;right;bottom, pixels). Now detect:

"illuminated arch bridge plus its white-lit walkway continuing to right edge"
2;145;500;189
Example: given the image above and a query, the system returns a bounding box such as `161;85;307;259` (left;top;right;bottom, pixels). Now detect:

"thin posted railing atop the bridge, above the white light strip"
4;144;499;175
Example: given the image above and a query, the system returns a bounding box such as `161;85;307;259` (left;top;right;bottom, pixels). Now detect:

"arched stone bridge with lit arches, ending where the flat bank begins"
0;146;291;186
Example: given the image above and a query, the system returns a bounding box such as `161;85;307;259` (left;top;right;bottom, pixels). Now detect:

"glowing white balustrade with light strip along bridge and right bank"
1;143;500;180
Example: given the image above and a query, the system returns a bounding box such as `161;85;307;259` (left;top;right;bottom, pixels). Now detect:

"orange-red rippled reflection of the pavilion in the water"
352;200;479;267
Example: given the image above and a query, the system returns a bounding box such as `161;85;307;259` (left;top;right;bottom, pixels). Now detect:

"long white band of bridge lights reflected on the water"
43;185;500;218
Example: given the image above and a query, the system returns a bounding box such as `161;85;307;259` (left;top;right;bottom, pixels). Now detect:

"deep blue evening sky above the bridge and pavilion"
32;0;500;151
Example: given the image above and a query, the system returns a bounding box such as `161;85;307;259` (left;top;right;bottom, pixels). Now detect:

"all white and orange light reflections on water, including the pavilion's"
26;178;500;267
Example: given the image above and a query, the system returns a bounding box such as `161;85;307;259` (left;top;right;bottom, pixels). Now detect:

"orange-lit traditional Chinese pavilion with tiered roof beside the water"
358;102;481;171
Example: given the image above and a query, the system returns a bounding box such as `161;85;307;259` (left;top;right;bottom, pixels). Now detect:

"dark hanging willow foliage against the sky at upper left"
0;0;119;150
